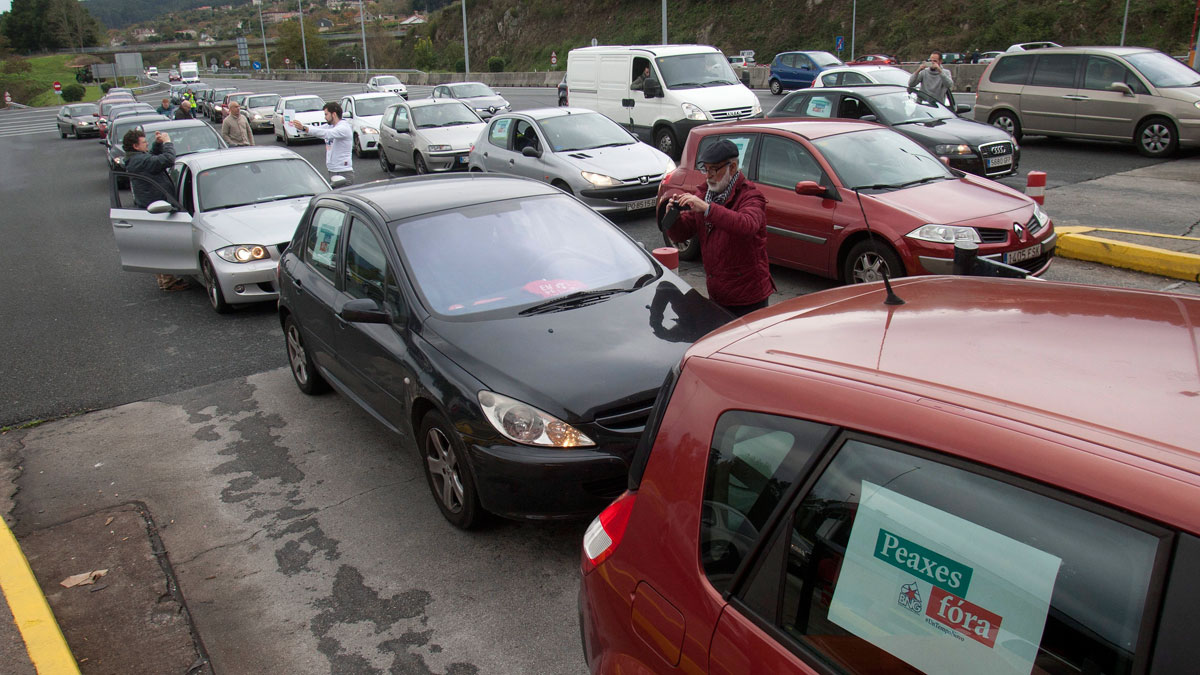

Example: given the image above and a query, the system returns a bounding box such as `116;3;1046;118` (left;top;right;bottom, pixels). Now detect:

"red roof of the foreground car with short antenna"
689;276;1200;466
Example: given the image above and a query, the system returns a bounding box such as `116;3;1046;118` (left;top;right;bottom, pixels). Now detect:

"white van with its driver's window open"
566;44;762;160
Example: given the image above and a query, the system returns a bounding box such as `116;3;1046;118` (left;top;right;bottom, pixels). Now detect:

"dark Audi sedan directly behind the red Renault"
767;84;1021;179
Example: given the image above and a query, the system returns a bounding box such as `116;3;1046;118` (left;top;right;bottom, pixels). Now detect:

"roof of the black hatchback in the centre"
326;173;563;221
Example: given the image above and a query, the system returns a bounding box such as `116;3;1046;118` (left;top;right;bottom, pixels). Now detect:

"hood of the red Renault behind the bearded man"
871;178;1033;225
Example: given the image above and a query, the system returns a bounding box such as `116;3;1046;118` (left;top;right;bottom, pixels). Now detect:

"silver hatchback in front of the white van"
469;108;676;214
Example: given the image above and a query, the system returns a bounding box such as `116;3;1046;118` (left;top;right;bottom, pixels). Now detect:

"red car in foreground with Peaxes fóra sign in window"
580;276;1200;675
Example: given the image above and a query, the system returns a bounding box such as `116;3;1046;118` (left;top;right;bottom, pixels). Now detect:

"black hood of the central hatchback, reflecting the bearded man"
425;273;732;422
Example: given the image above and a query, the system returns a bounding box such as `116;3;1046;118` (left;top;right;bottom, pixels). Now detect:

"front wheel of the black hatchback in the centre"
418;411;484;530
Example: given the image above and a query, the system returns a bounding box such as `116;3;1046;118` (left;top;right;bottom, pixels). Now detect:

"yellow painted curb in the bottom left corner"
0;522;79;675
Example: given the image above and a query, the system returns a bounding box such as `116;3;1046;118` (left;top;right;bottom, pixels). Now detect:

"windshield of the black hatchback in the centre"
396;195;656;316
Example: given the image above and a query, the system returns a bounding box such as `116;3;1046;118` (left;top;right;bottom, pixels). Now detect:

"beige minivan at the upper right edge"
974;47;1200;157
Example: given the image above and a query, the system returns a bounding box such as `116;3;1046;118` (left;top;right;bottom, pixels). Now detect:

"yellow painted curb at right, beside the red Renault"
1055;227;1200;281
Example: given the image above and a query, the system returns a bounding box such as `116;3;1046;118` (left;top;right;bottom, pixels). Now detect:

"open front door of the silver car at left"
108;172;200;275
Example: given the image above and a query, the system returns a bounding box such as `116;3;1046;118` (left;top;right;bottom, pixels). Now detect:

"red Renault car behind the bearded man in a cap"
656;119;1057;283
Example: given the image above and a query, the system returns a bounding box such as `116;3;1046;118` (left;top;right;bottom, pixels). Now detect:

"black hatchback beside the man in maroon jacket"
278;174;730;528
